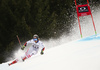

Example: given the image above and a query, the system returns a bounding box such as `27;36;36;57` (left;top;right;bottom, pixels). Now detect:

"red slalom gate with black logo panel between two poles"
75;0;97;38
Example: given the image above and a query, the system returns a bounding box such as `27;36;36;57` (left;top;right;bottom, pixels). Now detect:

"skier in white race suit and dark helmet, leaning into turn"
8;34;45;66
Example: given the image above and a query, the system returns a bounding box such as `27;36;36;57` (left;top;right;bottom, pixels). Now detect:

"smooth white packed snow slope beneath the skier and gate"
0;34;100;70
